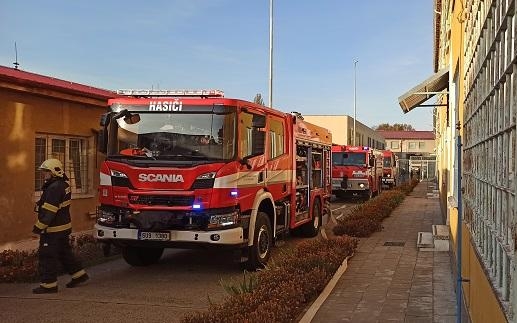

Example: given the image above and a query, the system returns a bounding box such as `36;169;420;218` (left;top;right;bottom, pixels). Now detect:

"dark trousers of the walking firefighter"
38;232;83;284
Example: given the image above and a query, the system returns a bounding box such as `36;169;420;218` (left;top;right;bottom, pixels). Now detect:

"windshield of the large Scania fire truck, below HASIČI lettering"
108;106;236;160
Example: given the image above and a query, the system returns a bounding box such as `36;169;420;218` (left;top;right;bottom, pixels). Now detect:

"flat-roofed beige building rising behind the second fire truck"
303;115;385;149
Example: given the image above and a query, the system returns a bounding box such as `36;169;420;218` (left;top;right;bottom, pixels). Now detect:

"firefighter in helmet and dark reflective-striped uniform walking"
32;159;88;294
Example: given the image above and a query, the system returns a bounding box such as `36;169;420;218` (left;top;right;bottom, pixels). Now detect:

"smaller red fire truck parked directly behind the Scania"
332;145;382;199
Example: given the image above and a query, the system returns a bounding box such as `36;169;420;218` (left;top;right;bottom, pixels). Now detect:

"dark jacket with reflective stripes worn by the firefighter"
32;176;72;234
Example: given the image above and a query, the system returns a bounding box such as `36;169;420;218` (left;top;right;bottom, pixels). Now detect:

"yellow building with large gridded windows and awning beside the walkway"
399;0;517;322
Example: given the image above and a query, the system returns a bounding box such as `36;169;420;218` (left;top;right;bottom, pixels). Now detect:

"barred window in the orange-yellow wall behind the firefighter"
34;134;89;194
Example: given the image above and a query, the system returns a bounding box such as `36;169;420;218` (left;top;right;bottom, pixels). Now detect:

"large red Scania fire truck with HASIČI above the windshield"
95;90;332;269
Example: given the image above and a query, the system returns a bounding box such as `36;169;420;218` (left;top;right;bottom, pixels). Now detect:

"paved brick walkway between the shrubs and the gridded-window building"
302;182;456;323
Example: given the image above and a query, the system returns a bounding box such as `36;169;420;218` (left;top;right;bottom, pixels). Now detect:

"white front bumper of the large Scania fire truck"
95;224;245;245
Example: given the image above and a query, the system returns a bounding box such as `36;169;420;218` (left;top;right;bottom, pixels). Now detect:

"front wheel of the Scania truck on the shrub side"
245;212;273;270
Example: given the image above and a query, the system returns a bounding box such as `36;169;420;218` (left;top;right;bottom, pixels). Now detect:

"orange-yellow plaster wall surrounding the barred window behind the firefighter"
0;89;106;244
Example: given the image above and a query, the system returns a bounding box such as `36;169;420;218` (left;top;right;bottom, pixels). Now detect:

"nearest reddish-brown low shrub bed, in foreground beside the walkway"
182;236;357;323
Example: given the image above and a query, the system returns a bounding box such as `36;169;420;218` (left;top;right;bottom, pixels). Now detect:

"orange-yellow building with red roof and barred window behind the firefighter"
0;66;115;250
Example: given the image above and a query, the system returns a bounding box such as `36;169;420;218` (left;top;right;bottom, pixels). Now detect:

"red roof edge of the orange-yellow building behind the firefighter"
0;65;117;99
